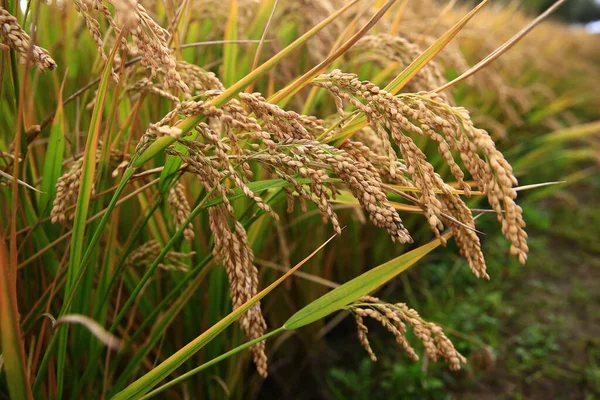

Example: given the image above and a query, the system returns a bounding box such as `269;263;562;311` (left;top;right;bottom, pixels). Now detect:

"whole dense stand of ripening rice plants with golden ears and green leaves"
0;0;593;399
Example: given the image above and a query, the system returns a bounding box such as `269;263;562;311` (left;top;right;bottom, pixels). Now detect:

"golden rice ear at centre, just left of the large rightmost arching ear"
240;93;412;243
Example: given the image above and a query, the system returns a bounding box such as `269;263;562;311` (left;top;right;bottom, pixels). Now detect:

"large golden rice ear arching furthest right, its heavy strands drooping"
314;70;528;270
